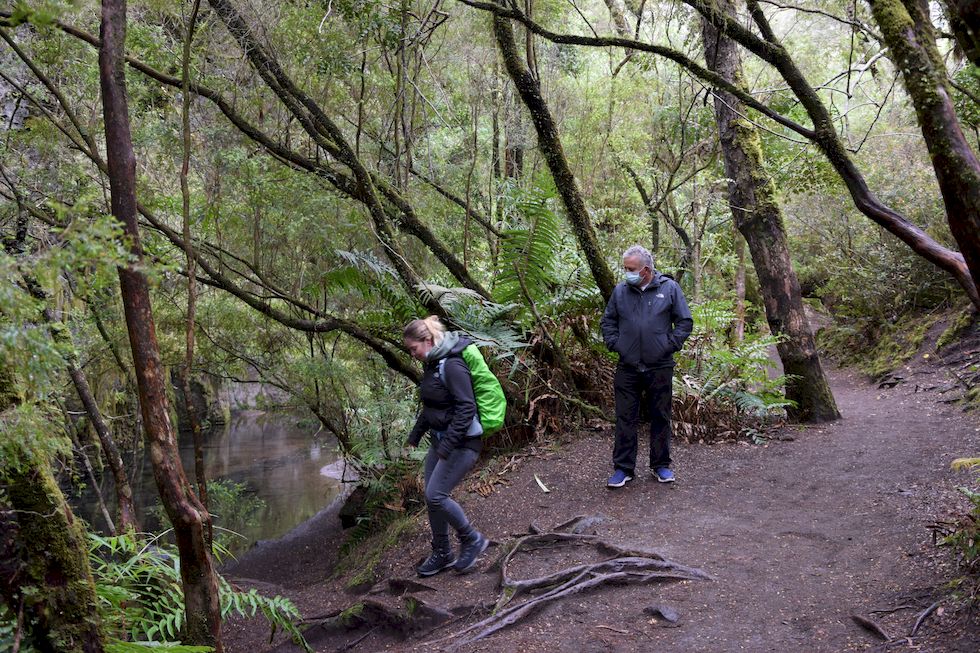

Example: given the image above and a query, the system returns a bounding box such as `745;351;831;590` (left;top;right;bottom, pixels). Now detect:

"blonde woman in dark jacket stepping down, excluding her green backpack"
402;315;489;577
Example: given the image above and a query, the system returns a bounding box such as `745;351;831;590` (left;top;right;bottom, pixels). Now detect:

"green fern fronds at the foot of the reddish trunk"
89;533;310;651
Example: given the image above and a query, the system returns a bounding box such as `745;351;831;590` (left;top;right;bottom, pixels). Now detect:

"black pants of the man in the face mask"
613;365;674;476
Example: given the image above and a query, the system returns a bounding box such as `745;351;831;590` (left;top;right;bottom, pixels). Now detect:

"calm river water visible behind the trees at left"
72;410;343;551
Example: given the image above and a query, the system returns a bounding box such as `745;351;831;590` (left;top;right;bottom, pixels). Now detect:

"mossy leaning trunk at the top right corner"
870;0;980;300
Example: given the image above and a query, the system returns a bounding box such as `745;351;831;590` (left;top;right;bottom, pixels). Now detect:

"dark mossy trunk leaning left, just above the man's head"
493;15;616;301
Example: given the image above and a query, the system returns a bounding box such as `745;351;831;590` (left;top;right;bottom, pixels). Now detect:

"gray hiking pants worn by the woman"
425;437;480;551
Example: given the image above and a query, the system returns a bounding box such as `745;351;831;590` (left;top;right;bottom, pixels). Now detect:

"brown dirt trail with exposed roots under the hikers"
229;364;980;652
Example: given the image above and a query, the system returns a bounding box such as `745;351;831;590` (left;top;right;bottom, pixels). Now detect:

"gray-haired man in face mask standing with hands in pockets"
601;245;694;488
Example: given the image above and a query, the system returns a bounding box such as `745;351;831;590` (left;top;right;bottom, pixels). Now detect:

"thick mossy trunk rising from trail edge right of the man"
702;0;840;422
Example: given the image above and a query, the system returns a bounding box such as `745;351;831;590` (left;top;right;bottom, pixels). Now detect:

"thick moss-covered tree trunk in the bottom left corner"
0;358;104;653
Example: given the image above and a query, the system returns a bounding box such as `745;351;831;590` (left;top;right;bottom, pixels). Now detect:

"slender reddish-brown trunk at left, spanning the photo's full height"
99;0;222;653
